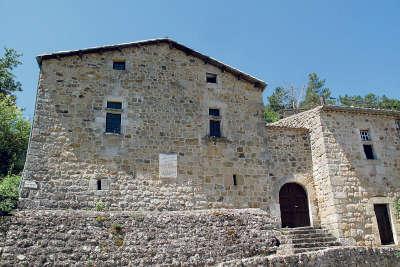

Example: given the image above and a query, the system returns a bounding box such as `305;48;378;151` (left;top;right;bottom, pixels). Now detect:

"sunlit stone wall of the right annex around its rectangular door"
321;111;400;245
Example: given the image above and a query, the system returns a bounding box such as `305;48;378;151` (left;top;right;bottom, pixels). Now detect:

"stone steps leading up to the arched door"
278;226;341;254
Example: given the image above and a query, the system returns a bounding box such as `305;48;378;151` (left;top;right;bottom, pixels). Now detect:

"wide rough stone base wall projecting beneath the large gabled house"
0;209;279;266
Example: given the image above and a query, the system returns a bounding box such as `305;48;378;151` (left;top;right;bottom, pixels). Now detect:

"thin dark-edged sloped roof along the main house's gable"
36;38;267;90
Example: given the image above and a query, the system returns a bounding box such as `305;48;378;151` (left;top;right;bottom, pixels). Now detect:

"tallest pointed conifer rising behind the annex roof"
300;72;335;109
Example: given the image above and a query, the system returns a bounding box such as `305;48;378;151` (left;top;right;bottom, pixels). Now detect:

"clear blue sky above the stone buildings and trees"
0;0;400;118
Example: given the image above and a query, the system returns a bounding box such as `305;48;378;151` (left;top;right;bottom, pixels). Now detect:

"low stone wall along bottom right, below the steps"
218;247;400;267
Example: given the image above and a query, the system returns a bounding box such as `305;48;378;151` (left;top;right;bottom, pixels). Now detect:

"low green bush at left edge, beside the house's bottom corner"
0;175;21;215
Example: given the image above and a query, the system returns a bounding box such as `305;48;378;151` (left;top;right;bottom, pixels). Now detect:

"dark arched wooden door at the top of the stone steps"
279;183;310;227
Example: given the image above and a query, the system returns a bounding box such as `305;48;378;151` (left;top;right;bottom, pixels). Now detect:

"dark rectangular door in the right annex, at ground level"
374;204;394;245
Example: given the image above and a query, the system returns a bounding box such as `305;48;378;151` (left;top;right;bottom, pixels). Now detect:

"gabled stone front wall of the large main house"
20;44;266;213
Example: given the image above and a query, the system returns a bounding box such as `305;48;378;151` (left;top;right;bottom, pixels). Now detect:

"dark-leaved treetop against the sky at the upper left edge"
0;48;22;101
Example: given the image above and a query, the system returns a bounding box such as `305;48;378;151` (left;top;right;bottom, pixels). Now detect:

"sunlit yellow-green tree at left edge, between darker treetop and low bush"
0;96;30;177
